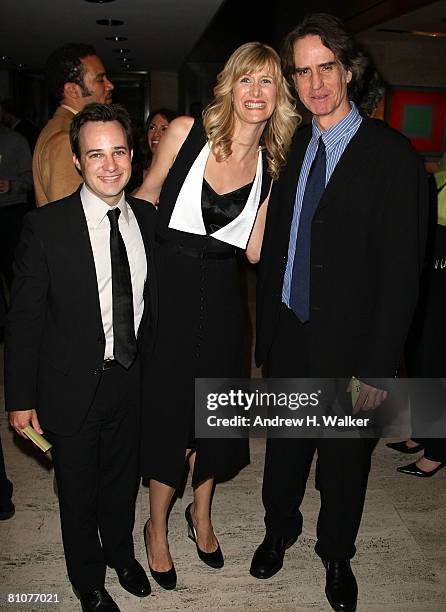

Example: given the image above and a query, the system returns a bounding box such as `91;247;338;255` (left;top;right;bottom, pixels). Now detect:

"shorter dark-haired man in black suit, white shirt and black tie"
5;103;157;611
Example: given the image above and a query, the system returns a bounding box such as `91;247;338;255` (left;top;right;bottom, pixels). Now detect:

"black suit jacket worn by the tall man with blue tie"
256;118;428;378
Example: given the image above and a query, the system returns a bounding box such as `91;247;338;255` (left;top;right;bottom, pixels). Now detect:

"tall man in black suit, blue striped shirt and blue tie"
251;14;427;610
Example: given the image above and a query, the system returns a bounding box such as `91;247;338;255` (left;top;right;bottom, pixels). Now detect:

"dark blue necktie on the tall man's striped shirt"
290;136;327;323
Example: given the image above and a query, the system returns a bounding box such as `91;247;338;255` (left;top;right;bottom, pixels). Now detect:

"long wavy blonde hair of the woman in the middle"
203;42;302;179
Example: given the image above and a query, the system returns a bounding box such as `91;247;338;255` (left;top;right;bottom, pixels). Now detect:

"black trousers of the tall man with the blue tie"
262;305;375;559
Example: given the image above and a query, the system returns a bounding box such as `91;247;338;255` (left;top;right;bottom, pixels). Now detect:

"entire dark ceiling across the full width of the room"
0;0;446;74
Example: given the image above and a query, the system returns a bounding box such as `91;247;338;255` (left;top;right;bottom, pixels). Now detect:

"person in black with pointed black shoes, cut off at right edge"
387;154;446;478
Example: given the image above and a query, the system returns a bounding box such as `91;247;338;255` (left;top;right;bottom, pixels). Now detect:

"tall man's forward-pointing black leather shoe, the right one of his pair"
323;559;358;612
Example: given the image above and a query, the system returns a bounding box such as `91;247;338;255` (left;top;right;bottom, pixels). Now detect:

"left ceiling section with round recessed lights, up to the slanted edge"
0;0;224;73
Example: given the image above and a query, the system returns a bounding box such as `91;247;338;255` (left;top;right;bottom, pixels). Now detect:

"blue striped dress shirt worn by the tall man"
282;102;362;308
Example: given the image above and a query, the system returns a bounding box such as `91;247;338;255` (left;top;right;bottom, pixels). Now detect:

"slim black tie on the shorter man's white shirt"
107;208;137;369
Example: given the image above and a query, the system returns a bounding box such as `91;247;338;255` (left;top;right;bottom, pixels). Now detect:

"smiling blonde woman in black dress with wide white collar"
137;43;300;588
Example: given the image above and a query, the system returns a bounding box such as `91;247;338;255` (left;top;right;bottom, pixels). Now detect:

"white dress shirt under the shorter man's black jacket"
80;184;147;359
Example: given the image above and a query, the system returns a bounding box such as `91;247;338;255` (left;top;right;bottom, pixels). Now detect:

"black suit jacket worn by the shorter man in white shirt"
5;190;157;435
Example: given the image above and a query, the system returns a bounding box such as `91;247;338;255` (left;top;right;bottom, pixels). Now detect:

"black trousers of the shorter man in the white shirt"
45;362;140;592
